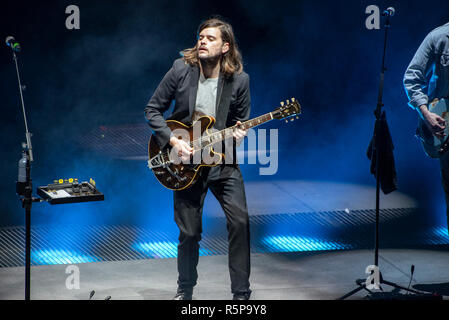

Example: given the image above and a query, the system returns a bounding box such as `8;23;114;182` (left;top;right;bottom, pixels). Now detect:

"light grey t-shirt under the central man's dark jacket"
193;74;218;120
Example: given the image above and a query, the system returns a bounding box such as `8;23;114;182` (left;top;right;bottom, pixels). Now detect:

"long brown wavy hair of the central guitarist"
181;17;243;76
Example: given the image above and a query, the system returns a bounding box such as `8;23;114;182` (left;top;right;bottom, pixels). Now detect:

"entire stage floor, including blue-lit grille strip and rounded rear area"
0;181;449;300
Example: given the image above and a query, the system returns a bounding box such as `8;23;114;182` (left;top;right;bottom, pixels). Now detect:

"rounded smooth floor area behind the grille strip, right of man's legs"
204;180;417;217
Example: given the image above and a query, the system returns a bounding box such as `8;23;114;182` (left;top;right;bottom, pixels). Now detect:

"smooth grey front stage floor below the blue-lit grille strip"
0;247;449;300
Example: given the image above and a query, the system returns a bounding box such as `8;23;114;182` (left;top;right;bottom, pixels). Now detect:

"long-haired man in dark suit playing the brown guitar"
145;18;251;300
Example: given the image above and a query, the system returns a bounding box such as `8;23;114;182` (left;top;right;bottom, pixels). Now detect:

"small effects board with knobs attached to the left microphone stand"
37;178;104;204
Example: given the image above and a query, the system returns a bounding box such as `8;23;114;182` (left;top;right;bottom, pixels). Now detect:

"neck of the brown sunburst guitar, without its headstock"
191;112;274;151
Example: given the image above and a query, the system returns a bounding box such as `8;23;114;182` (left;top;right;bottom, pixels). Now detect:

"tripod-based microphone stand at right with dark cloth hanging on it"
338;14;422;300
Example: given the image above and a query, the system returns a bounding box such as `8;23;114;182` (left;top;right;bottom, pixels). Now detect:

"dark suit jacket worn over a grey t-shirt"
145;58;251;149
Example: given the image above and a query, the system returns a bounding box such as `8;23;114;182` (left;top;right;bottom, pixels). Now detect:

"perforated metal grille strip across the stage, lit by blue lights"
0;209;440;267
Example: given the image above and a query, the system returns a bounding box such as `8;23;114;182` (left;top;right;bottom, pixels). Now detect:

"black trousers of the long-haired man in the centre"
174;165;250;293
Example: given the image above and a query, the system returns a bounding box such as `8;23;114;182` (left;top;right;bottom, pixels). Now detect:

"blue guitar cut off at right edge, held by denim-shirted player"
416;99;449;158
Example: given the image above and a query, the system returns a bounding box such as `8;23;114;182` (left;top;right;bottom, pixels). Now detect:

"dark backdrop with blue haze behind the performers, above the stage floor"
0;0;449;228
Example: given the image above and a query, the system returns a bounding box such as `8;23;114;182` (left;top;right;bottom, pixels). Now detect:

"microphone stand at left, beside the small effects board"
12;45;42;300
